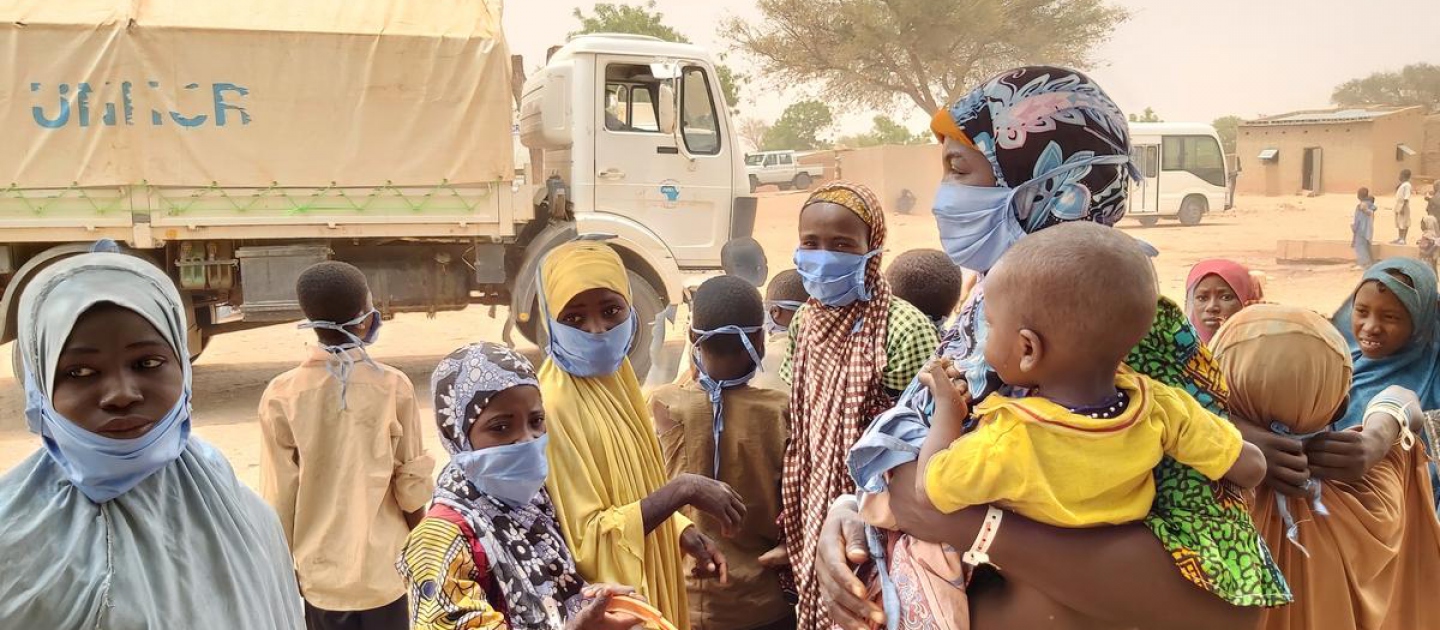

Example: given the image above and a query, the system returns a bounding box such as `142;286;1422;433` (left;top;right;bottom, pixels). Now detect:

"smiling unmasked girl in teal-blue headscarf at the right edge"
1324;257;1440;503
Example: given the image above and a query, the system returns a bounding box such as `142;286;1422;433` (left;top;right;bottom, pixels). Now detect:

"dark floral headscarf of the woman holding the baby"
930;66;1135;394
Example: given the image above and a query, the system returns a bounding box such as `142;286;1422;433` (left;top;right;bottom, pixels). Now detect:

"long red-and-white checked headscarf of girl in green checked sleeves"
780;181;893;629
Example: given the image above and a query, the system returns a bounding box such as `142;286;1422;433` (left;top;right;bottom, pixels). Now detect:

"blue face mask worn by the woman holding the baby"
933;155;1133;273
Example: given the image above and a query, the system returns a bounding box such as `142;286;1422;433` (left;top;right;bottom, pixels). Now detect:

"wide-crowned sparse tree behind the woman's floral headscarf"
723;0;1129;114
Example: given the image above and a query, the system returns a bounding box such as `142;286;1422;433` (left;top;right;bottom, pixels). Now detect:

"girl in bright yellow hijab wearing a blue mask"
540;240;744;630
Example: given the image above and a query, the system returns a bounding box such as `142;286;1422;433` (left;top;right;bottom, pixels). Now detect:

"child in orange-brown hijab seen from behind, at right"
1212;305;1440;630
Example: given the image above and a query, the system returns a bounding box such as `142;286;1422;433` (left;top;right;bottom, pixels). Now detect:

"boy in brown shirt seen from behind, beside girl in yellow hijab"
651;276;795;630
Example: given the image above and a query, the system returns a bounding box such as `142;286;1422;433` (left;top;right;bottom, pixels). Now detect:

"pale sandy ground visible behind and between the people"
0;193;1399;488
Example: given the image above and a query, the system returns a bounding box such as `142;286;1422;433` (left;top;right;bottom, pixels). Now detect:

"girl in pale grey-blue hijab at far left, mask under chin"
0;248;304;630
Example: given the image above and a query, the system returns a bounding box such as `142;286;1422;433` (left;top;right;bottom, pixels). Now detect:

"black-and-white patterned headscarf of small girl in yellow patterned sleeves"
431;342;585;630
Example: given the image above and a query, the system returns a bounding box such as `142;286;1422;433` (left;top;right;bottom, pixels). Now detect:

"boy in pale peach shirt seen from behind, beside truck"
259;262;435;630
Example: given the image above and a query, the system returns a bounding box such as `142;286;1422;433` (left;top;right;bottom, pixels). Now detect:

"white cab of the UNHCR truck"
520;35;755;270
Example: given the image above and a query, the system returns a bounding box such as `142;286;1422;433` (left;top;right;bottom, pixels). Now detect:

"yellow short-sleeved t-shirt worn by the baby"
924;368;1243;526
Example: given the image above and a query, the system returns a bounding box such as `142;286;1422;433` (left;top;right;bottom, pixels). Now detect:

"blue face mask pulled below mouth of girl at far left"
24;378;190;503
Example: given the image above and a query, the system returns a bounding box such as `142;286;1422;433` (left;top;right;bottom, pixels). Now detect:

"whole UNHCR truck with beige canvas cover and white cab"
0;0;756;378
